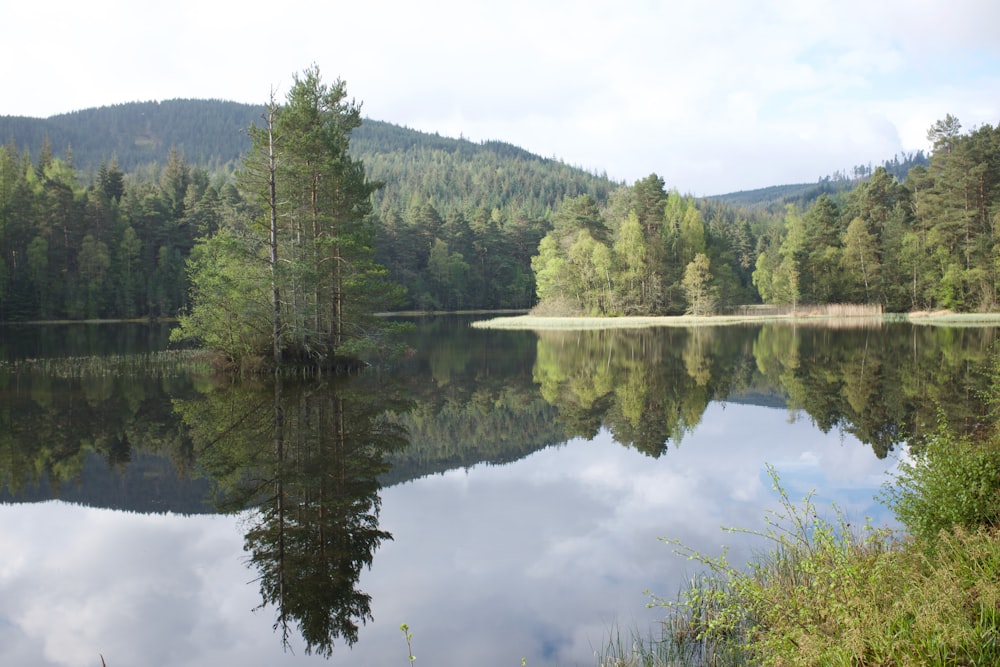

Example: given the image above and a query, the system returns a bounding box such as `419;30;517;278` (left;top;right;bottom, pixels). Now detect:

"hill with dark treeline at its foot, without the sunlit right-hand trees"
0;100;618;321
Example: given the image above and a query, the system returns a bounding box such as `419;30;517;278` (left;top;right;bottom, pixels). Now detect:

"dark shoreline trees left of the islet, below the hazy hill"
0;146;230;321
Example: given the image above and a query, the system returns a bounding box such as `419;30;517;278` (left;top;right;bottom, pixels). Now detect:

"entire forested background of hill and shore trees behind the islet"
0;100;988;321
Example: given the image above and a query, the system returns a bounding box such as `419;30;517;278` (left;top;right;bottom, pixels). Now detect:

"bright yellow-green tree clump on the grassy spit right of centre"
531;179;744;315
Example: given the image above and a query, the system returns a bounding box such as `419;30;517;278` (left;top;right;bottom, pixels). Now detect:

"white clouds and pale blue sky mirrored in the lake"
0;403;894;667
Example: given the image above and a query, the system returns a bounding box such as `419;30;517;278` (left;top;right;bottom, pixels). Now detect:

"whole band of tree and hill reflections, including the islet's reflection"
0;319;996;656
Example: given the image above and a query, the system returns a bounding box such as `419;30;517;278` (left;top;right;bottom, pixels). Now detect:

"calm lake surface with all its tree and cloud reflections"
0;317;996;667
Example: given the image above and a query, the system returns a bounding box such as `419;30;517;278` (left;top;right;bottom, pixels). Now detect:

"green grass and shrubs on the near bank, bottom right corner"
600;470;1000;667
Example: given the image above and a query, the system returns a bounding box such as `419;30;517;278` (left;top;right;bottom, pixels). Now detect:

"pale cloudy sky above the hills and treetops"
0;0;1000;196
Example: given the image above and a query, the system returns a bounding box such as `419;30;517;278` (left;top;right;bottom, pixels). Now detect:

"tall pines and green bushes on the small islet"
177;67;399;366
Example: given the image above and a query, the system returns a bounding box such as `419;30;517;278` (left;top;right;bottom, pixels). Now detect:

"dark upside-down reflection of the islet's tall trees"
175;378;407;657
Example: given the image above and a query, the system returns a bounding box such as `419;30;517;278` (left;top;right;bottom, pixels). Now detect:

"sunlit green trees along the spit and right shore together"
532;116;1000;315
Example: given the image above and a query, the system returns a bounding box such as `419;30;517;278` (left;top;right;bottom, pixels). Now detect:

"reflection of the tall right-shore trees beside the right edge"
754;325;996;458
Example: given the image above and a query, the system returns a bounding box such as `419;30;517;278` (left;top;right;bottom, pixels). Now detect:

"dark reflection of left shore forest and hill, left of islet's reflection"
0;363;201;513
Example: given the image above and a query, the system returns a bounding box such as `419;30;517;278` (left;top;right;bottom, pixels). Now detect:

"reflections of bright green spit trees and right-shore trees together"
534;323;995;457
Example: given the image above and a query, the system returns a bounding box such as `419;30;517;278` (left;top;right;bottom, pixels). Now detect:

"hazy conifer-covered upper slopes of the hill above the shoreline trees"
0;100;619;214
